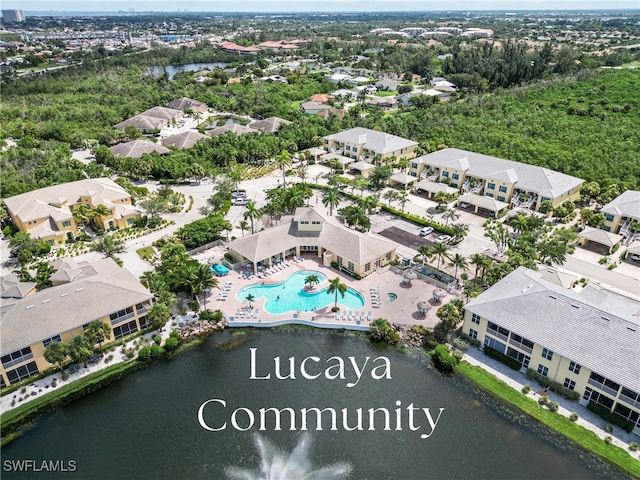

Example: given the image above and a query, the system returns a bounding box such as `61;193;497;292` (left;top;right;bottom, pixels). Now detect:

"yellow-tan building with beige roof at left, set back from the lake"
4;178;141;246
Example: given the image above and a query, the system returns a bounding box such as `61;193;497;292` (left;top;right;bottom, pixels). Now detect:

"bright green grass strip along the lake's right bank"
456;362;640;477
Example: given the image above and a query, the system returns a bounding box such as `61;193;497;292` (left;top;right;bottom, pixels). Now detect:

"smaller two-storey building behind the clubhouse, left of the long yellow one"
323;127;418;162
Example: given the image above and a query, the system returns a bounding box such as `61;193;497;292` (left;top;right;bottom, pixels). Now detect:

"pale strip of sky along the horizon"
7;0;640;13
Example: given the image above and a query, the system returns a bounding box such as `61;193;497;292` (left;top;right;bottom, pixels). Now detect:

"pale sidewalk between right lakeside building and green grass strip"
463;347;640;458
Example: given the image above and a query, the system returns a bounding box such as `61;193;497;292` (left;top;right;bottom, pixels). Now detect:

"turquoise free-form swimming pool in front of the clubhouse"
236;270;364;314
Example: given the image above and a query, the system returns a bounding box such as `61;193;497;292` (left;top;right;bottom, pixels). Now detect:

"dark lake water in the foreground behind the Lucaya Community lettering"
2;328;626;480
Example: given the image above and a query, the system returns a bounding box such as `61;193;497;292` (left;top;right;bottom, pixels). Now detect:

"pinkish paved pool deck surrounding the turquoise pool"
207;256;455;330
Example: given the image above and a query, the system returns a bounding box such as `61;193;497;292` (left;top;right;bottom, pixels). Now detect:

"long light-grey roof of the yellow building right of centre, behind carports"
413;148;584;198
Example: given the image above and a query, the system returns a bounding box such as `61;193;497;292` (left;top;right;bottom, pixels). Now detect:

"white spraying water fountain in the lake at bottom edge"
225;433;353;480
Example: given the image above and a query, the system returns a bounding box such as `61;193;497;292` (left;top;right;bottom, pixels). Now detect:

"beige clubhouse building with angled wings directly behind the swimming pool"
229;207;396;277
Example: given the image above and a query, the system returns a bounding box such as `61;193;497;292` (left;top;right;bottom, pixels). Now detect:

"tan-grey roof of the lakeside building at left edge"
0;258;153;355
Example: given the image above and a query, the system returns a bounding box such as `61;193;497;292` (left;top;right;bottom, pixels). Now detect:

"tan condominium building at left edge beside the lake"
0;258;153;387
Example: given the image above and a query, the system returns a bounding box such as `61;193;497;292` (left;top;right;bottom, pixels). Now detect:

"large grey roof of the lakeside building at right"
465;267;640;392
